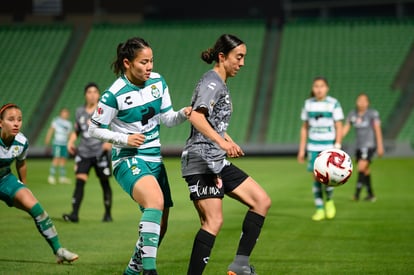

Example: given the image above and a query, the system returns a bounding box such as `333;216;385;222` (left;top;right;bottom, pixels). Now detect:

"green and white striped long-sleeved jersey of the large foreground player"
89;72;186;168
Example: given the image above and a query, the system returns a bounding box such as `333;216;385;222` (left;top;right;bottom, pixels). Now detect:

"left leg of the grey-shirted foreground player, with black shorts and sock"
185;174;224;275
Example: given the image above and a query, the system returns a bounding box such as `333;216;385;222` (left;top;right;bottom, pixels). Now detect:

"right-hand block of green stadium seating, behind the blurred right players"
266;19;414;144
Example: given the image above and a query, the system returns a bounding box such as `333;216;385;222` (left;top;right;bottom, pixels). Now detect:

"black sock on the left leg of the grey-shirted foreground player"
187;229;216;275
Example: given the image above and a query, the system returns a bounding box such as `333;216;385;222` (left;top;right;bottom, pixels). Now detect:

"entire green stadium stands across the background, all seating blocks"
0;18;414;155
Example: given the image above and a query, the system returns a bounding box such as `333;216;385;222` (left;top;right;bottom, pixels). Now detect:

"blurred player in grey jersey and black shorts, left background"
63;82;112;222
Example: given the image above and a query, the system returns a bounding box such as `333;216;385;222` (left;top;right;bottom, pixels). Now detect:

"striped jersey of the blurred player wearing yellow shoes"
301;96;344;152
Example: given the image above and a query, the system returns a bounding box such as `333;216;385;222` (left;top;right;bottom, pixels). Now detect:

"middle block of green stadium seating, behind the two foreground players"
35;20;265;146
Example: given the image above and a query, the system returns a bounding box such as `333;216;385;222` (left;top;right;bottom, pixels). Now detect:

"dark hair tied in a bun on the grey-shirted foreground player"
201;34;244;64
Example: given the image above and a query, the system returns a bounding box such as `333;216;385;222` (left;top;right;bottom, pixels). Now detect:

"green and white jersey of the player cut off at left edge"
0;131;29;179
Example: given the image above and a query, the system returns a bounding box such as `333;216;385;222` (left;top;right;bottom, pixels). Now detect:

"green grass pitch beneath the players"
0;157;414;275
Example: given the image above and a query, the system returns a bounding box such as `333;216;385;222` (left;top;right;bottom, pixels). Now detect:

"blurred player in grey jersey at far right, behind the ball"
343;93;384;202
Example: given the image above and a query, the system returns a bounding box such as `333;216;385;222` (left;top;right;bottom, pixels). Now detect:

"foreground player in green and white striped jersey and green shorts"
89;37;191;275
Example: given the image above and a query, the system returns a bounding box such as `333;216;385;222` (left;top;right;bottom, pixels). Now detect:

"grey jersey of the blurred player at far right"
346;109;381;149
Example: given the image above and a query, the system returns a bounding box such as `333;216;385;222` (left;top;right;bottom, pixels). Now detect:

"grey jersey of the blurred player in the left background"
74;106;103;158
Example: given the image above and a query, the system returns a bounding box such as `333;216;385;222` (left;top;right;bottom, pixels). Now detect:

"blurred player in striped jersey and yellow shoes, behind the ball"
297;76;344;221
